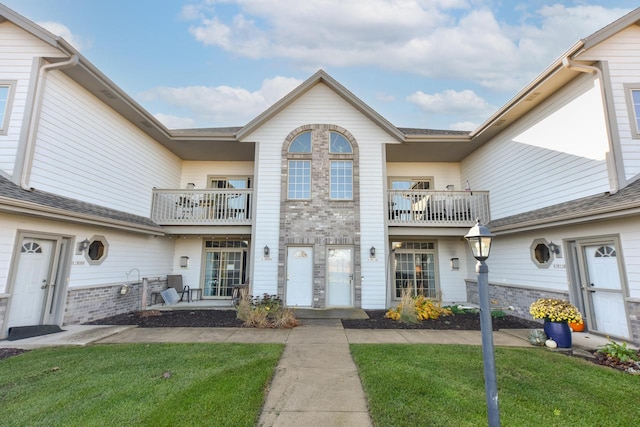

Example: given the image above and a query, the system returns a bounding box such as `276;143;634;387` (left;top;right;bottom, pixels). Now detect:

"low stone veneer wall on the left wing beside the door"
63;279;167;325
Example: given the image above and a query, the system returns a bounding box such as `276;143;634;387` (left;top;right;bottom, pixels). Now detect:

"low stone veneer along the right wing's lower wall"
466;280;640;344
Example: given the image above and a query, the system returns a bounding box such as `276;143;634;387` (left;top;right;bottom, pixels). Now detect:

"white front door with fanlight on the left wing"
8;237;57;327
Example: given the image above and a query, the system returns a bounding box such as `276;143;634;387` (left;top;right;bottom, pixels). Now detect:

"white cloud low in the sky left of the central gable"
139;76;301;128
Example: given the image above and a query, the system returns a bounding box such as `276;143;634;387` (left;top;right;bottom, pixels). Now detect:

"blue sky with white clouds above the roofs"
0;0;638;130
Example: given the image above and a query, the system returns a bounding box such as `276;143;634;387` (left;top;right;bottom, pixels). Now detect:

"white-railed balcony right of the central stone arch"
387;190;490;227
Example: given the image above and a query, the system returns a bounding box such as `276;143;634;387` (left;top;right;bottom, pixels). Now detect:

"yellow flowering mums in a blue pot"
529;298;583;348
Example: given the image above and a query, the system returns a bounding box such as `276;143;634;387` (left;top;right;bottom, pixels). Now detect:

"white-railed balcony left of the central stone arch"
151;189;253;225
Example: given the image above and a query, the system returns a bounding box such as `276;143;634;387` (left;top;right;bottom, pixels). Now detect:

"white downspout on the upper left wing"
20;54;80;191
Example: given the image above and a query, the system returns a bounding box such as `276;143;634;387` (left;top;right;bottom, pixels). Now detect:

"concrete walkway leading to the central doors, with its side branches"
0;319;608;427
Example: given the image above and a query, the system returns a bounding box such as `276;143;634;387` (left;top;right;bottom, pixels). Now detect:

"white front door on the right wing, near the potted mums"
583;243;630;338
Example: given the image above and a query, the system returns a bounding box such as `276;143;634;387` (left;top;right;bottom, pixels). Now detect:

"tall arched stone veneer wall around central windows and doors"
278;124;362;308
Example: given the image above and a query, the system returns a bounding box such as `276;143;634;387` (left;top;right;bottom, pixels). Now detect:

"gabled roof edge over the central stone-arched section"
236;70;404;141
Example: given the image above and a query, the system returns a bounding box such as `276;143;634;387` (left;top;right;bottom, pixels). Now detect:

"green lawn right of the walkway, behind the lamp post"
351;344;640;427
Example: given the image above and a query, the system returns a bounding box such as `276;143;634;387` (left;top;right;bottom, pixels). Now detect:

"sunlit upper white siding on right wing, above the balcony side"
461;75;610;219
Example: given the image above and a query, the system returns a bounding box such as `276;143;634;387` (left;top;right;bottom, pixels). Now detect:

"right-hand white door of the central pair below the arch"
327;248;353;307
